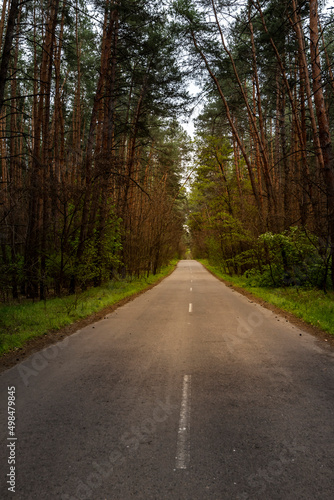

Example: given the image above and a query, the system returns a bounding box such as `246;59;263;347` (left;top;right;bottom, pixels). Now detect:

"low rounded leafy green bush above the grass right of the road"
198;227;330;289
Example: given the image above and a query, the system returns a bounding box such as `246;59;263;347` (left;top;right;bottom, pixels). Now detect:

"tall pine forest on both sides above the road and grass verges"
0;0;334;302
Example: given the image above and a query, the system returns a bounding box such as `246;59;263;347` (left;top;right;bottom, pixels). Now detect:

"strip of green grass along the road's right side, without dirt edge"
198;259;334;336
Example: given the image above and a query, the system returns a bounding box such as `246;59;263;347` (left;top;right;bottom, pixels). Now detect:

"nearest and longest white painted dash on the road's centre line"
175;375;191;469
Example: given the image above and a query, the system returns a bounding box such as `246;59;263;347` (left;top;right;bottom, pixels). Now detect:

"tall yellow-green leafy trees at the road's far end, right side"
188;129;260;274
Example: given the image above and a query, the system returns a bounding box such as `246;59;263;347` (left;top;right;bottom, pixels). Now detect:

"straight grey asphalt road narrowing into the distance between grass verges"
0;260;334;500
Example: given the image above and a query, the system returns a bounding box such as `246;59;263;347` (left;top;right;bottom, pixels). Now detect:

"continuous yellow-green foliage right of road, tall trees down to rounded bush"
188;133;330;290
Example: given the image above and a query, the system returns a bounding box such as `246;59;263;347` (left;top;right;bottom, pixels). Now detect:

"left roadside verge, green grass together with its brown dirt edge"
0;260;177;373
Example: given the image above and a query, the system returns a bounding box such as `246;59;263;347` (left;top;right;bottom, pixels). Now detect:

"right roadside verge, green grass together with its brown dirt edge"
198;259;334;346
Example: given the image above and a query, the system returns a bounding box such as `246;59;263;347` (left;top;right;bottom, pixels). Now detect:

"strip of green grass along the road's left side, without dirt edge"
0;260;177;355
